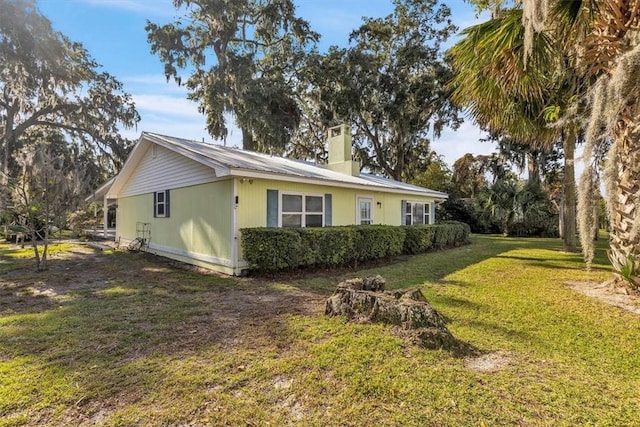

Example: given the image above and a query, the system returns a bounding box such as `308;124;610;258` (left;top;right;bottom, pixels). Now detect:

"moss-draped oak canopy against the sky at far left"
0;0;139;184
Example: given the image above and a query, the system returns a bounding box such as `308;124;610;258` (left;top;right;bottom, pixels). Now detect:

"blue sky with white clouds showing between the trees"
37;0;494;165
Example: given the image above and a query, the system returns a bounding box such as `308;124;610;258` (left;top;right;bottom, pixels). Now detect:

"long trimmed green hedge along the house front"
241;221;470;271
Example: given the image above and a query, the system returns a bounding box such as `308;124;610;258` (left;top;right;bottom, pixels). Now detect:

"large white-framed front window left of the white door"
280;193;324;227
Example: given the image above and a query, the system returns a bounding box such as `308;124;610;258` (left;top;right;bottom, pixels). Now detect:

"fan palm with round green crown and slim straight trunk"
450;8;580;252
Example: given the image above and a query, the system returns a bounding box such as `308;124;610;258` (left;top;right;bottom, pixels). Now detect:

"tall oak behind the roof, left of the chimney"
146;0;318;152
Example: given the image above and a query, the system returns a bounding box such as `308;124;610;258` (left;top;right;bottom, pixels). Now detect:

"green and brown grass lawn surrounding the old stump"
0;236;640;426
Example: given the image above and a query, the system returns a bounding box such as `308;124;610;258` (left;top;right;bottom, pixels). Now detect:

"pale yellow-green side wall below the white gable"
117;179;234;273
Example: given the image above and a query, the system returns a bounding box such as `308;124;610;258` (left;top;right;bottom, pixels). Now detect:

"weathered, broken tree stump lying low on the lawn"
325;275;458;349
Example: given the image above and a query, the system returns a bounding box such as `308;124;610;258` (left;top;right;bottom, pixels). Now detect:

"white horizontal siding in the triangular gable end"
119;144;215;197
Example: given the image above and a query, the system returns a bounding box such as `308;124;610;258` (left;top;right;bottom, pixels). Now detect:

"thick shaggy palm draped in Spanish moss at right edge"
523;0;640;289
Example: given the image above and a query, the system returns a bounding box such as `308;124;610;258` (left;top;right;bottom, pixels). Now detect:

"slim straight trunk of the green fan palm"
562;135;576;252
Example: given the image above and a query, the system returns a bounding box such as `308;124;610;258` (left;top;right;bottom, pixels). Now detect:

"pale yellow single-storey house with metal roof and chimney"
104;125;447;274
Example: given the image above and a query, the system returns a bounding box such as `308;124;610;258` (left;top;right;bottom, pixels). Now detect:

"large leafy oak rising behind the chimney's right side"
296;0;460;181
